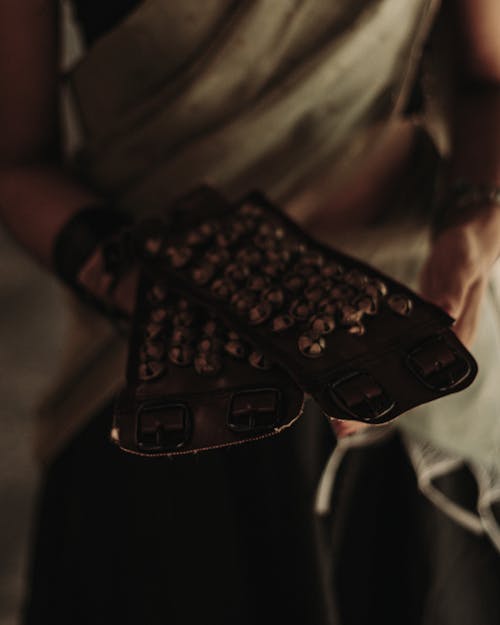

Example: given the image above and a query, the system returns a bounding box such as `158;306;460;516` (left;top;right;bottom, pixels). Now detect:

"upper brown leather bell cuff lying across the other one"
144;188;477;424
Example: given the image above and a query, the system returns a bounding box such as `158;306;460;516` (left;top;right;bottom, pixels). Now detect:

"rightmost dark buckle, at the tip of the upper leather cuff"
406;336;471;391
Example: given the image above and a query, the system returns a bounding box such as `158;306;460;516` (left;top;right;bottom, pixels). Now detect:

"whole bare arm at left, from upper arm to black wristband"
0;0;105;267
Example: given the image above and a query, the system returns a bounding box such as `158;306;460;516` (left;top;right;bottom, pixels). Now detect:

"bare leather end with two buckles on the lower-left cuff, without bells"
114;278;304;455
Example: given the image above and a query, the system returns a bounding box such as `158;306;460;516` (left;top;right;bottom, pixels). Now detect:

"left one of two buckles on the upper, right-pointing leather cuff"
329;371;395;423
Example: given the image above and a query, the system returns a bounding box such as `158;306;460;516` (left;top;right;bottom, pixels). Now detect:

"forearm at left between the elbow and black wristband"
0;163;101;268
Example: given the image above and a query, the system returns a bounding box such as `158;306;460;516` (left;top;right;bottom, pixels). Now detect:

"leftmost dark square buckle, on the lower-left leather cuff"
137;402;191;452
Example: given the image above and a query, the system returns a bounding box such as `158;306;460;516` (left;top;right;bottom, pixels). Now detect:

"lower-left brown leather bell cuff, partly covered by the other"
112;189;304;456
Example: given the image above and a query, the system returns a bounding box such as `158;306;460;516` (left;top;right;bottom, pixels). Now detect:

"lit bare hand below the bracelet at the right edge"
420;205;500;346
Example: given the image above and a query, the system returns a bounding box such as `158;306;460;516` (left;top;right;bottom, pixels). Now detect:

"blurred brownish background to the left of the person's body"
0;0;81;625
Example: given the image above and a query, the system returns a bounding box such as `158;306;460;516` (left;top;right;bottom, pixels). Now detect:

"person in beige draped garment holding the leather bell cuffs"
0;0;500;625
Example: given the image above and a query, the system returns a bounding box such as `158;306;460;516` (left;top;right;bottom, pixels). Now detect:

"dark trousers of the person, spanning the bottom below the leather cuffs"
24;409;500;625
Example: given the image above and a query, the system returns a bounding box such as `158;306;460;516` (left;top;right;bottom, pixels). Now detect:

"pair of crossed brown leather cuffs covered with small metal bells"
114;188;477;455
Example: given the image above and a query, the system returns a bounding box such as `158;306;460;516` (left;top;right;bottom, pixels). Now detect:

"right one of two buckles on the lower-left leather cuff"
227;388;281;433
